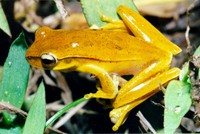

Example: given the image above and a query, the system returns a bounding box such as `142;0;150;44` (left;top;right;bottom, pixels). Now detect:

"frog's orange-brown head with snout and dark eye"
26;27;75;70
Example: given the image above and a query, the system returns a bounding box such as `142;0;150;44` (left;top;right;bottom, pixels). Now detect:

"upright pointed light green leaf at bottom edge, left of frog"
23;83;46;134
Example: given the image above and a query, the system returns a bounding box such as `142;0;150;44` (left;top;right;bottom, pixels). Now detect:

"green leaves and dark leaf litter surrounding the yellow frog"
0;0;200;134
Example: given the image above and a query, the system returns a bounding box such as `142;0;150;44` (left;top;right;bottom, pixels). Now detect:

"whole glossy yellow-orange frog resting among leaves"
26;6;181;131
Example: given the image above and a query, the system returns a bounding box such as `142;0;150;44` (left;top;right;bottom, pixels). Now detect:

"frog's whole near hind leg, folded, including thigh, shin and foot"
110;52;180;130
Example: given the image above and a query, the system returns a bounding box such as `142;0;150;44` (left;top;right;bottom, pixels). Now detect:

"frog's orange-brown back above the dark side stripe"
31;30;166;61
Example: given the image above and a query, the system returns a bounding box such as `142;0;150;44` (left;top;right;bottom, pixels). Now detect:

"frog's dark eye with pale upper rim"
41;53;57;68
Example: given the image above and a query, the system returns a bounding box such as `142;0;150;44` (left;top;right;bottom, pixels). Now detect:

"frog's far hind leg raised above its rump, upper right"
117;5;181;55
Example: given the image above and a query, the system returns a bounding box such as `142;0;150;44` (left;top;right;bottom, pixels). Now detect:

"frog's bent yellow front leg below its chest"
77;64;118;99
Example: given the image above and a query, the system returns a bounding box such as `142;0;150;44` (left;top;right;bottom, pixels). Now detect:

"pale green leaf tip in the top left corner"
0;1;11;37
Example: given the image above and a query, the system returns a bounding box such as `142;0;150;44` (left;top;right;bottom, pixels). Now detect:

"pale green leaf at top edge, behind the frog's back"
81;0;137;27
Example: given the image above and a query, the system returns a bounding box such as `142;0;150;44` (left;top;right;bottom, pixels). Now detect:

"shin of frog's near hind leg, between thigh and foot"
112;68;180;107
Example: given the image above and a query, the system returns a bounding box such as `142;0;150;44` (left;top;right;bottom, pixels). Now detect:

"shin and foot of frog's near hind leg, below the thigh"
110;68;180;131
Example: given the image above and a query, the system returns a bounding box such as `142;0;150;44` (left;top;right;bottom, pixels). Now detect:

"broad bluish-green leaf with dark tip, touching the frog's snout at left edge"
0;33;30;123
